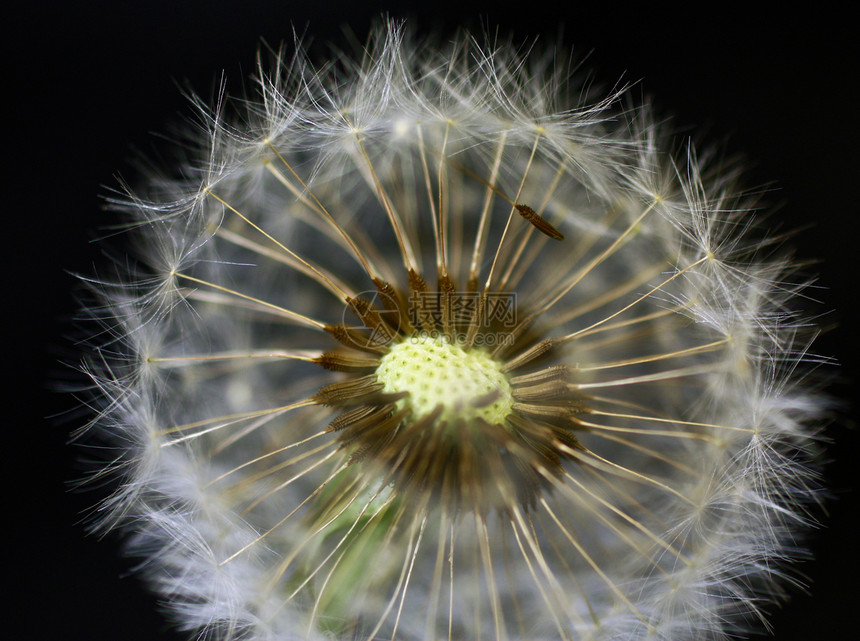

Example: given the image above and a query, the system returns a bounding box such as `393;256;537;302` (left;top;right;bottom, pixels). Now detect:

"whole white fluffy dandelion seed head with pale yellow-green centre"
79;25;822;641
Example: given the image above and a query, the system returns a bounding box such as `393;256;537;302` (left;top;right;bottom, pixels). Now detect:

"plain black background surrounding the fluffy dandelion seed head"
8;0;860;641
